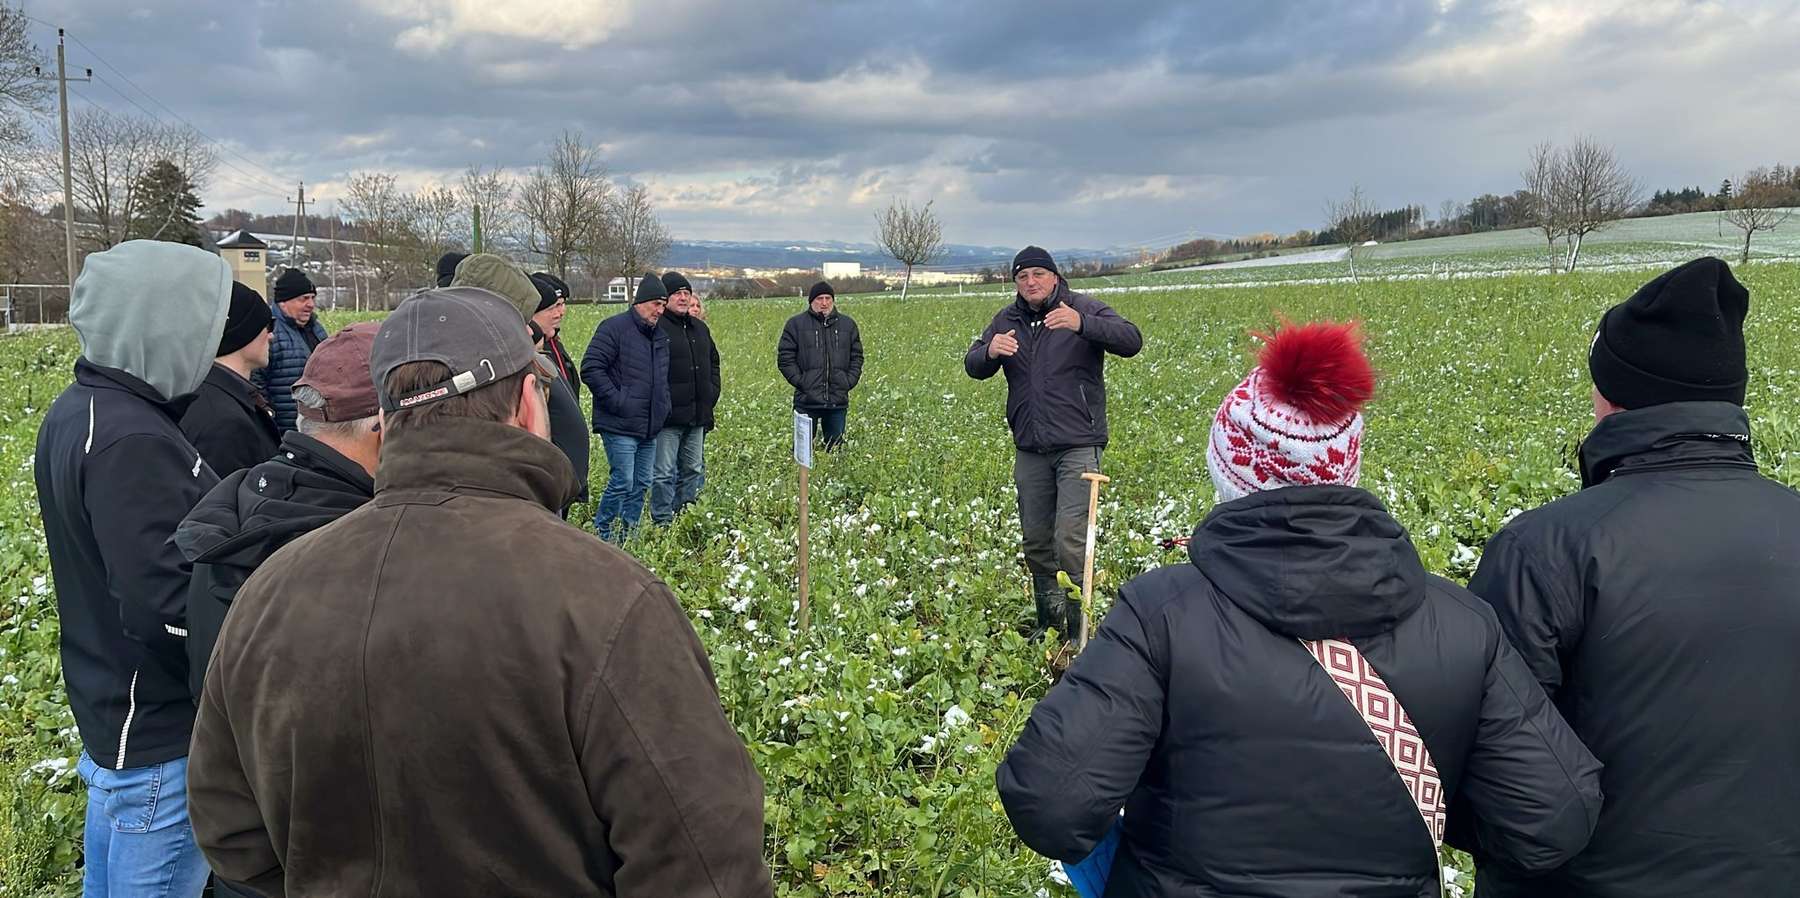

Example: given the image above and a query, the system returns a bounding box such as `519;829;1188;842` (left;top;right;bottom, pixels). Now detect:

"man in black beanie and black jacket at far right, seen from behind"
1469;257;1800;898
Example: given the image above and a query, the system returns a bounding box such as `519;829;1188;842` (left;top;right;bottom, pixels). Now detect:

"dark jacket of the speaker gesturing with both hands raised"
963;283;1143;452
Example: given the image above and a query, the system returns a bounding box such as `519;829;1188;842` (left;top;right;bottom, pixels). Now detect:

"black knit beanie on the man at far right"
1588;256;1750;409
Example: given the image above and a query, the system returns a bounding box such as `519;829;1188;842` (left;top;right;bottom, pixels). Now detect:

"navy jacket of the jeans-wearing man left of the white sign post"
581;308;670;439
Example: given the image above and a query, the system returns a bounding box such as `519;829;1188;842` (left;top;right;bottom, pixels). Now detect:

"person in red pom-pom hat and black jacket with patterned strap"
997;324;1602;898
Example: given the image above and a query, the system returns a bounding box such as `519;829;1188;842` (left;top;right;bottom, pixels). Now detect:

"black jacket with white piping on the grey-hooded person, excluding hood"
34;358;218;770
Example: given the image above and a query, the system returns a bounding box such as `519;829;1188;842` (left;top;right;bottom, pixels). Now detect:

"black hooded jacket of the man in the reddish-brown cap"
175;430;374;702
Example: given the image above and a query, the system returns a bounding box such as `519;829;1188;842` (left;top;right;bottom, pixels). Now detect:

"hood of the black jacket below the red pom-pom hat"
1188;486;1426;639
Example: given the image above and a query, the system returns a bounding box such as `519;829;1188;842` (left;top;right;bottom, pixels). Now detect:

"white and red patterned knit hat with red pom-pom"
1206;322;1375;502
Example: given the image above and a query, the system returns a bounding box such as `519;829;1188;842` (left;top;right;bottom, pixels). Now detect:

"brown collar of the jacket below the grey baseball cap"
374;418;580;513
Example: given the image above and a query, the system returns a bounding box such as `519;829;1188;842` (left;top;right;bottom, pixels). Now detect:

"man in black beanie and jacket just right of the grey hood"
182;281;281;477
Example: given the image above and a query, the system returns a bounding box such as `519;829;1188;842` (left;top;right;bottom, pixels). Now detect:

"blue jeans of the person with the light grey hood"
76;752;207;898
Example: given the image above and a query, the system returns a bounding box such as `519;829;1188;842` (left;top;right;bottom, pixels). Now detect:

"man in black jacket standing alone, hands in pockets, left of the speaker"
776;281;862;452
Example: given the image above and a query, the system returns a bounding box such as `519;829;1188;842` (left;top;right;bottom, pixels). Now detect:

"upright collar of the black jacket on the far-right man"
1580;401;1757;488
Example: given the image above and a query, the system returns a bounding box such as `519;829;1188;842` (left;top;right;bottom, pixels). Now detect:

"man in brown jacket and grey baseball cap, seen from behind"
189;288;774;898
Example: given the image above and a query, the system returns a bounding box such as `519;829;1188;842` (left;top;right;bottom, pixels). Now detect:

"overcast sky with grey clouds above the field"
24;0;1800;248
